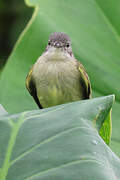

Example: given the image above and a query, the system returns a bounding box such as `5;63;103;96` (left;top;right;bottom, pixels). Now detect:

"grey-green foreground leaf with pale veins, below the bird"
0;96;120;180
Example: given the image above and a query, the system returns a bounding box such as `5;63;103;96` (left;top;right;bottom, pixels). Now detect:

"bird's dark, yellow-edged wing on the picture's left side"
26;67;43;109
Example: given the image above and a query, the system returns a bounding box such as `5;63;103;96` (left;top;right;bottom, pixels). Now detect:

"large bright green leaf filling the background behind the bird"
0;0;120;154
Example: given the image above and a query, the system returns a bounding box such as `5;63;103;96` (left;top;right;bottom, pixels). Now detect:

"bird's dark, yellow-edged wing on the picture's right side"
77;61;92;99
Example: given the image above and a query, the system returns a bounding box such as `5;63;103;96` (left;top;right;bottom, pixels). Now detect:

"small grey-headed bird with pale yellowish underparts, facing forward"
26;32;91;109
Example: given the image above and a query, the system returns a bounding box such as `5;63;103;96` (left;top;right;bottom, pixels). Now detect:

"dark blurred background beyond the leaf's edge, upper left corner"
0;0;33;68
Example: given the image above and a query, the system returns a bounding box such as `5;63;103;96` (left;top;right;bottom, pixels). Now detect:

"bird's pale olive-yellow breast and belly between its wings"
33;53;83;107
